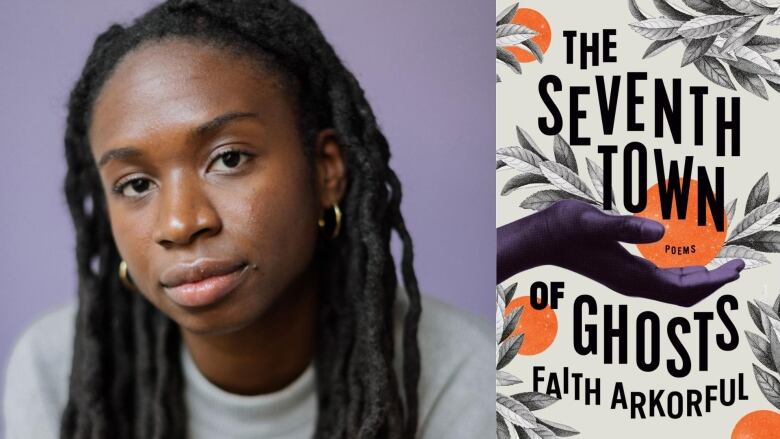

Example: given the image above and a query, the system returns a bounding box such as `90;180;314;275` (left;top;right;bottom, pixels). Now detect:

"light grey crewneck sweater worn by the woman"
3;292;495;439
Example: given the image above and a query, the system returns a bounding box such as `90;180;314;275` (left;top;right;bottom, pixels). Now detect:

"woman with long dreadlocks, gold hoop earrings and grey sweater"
4;0;494;439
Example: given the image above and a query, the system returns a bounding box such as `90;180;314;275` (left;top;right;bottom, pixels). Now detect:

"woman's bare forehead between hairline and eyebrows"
89;39;291;152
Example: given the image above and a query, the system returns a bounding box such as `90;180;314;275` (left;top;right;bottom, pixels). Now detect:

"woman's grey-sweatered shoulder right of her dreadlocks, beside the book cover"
396;291;495;439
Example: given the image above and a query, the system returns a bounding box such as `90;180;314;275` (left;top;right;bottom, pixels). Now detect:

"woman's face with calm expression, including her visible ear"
89;39;343;333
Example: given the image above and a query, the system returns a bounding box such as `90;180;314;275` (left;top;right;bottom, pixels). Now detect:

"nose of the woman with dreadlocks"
154;172;222;248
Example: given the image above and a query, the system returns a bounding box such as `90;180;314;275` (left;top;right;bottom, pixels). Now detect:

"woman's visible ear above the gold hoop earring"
314;128;347;208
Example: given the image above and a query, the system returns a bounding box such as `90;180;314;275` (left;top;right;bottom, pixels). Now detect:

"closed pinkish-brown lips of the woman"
163;264;249;307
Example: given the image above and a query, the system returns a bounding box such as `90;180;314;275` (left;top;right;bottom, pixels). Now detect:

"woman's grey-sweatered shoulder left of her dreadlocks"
3;302;76;439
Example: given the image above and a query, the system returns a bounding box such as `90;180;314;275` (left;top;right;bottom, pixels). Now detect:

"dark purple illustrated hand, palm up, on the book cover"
498;200;745;306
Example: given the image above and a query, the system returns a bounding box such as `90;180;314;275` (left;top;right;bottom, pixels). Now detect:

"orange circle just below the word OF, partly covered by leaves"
505;296;558;355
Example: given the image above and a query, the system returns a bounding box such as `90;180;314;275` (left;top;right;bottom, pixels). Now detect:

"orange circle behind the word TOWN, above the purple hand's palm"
636;180;728;268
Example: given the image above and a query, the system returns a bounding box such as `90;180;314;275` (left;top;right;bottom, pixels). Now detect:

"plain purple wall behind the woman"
0;0;495;428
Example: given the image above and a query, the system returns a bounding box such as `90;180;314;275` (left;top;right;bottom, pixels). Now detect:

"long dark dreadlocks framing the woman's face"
60;0;421;439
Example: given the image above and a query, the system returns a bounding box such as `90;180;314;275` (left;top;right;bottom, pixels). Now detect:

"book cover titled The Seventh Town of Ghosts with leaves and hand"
496;0;780;439
